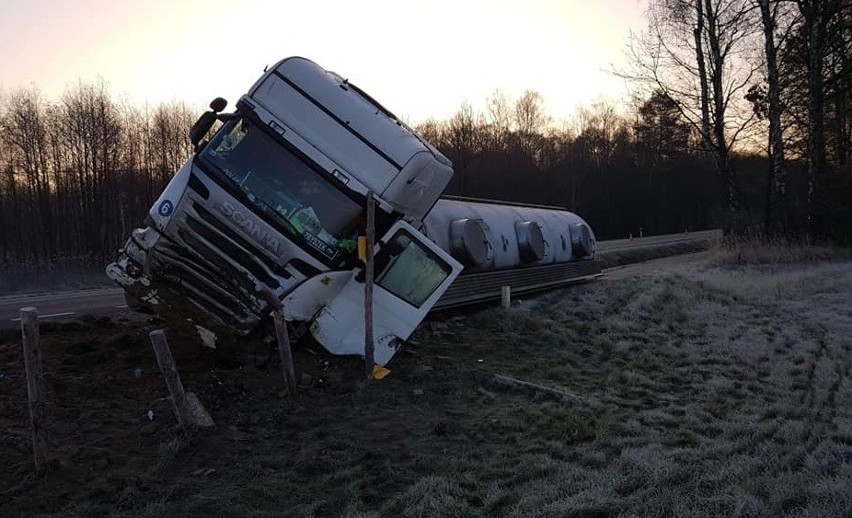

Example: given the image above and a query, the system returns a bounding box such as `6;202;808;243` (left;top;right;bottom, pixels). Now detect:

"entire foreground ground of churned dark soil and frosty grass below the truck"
0;263;852;516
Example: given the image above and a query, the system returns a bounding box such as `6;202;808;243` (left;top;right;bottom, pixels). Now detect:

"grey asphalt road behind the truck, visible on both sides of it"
0;230;720;329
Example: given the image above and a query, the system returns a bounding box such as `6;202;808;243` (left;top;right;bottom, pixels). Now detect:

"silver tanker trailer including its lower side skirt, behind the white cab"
423;196;602;309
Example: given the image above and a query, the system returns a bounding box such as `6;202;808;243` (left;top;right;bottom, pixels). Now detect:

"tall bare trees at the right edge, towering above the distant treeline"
619;0;852;241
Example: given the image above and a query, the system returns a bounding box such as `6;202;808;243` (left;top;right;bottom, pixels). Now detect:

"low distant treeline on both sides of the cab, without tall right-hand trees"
0;84;720;265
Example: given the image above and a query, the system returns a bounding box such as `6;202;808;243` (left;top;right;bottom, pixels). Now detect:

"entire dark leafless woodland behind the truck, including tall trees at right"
0;0;852;268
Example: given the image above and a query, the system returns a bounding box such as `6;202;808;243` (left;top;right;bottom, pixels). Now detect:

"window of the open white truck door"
375;230;453;307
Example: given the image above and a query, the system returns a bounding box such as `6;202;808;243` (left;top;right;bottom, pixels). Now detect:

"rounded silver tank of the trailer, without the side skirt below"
423;198;596;273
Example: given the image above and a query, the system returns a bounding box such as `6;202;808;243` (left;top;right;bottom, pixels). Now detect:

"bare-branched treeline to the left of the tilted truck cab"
0;83;196;265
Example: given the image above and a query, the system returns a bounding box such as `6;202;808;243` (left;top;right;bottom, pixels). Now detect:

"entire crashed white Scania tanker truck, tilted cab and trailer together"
107;57;600;365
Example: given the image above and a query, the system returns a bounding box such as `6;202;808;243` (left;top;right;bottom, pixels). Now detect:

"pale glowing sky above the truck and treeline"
0;0;645;122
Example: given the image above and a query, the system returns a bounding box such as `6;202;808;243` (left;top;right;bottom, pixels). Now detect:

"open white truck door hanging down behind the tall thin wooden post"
311;221;462;365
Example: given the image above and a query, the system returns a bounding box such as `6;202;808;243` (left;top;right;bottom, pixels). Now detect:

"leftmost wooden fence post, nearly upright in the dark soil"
20;307;48;472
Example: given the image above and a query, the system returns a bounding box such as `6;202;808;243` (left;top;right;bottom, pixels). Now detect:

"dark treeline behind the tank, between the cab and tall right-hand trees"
417;91;722;238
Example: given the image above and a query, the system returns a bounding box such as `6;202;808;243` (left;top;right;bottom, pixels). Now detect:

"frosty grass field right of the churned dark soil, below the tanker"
172;262;852;517
